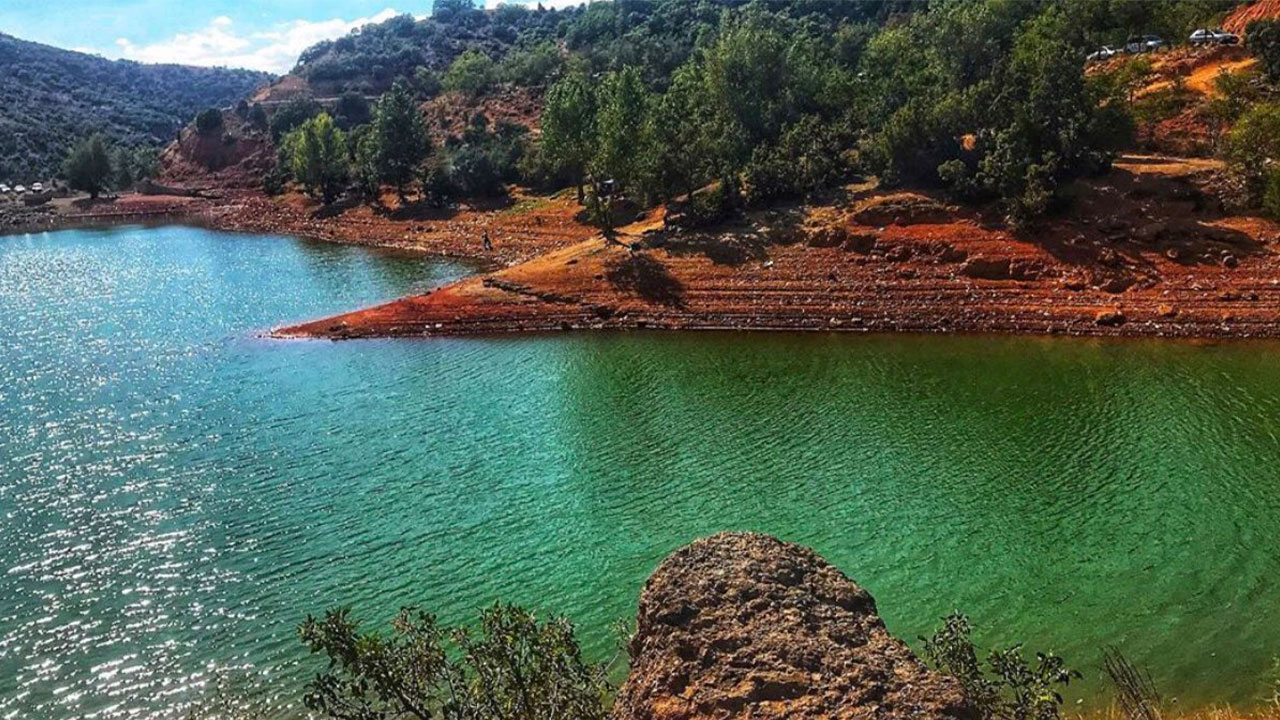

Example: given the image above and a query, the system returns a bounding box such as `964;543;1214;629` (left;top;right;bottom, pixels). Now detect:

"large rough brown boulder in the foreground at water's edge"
613;533;975;720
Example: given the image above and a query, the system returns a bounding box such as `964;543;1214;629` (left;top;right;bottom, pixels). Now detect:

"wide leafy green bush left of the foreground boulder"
300;605;609;720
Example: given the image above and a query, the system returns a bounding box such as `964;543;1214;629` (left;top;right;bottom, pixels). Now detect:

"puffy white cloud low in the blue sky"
115;8;399;73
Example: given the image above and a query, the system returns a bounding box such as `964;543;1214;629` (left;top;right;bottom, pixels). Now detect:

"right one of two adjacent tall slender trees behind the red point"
594;68;649;196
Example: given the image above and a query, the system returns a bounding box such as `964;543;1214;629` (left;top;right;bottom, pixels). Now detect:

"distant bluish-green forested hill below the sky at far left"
0;33;271;182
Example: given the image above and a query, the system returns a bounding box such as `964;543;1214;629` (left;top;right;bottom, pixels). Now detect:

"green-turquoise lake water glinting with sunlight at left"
0;228;1280;720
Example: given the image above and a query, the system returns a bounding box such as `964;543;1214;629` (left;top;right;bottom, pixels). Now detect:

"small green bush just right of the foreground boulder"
920;612;1080;720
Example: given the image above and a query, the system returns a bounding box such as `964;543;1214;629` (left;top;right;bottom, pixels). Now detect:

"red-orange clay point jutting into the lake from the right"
280;151;1280;340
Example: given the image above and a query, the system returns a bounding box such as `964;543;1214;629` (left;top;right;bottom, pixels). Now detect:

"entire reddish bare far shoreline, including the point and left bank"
20;156;1280;341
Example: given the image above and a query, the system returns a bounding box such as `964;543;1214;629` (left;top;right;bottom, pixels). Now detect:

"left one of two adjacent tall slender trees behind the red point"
541;69;595;204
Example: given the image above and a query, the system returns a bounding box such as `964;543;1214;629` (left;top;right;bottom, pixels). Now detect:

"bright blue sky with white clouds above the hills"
0;0;585;73
